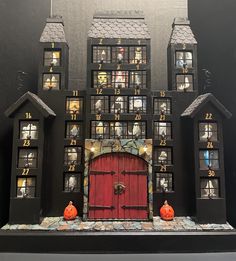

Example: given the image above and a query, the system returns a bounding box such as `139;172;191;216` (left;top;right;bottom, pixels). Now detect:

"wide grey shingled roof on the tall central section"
88;10;150;39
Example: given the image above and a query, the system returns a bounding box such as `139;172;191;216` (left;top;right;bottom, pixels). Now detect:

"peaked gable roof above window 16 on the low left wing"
5;92;56;118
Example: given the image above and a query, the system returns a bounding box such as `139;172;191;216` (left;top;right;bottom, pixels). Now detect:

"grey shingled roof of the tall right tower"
169;18;197;44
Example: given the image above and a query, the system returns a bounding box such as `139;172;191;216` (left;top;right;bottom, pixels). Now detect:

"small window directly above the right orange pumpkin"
156;172;173;192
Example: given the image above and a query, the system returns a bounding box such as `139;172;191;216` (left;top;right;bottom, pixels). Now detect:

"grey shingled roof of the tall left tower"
40;16;66;43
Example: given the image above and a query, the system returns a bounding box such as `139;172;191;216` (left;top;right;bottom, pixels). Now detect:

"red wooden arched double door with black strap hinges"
89;153;148;220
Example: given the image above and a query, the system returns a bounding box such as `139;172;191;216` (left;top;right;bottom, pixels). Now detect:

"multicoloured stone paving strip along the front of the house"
1;217;234;231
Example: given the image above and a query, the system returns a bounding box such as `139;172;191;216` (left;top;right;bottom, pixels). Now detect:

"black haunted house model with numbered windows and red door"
6;11;230;223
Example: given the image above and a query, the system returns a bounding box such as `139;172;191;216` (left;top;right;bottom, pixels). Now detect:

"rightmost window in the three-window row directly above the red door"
127;121;146;139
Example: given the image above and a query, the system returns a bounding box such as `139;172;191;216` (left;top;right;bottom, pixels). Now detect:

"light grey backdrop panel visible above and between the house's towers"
53;0;187;89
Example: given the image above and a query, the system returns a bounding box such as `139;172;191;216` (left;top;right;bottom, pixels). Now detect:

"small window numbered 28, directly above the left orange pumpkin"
64;173;81;192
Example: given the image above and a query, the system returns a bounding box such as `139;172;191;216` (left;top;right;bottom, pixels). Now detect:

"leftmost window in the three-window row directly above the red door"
91;121;109;139
